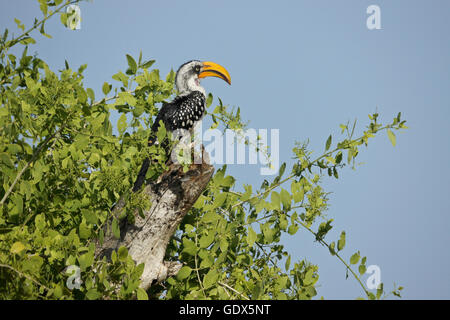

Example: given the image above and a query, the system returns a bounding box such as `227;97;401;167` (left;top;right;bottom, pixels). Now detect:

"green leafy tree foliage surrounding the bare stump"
0;0;406;299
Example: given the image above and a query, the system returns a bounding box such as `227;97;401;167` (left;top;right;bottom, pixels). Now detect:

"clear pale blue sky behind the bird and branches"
0;0;450;299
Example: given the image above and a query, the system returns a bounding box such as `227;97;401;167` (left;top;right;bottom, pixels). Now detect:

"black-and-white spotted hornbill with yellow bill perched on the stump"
133;60;231;192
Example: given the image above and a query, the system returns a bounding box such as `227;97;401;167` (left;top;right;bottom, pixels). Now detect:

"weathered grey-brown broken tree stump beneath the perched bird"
96;150;214;290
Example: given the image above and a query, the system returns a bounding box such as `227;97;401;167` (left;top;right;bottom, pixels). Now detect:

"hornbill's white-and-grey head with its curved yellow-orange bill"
175;60;231;94
